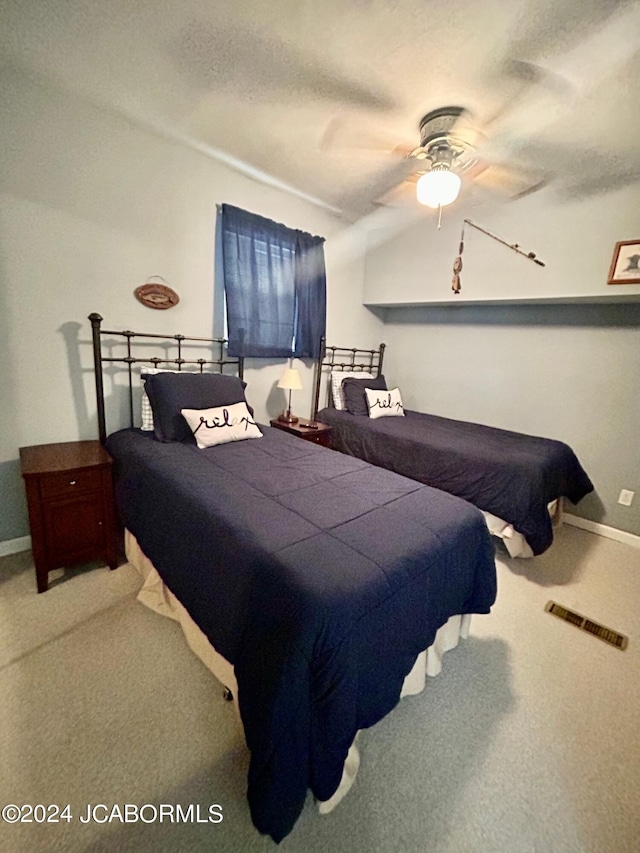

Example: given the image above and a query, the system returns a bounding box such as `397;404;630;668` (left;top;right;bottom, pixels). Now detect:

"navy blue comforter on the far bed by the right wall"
317;408;593;554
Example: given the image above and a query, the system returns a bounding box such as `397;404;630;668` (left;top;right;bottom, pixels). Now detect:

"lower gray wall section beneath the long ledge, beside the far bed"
376;304;640;535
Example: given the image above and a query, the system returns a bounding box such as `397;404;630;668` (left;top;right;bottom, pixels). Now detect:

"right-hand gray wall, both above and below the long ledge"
364;184;640;535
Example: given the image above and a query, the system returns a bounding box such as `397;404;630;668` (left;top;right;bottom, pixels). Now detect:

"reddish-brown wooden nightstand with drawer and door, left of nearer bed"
20;441;118;592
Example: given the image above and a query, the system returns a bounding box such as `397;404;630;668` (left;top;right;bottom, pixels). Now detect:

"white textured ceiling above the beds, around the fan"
0;0;640;212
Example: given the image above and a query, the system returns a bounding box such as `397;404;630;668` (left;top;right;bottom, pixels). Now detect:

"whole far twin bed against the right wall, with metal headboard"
313;342;593;557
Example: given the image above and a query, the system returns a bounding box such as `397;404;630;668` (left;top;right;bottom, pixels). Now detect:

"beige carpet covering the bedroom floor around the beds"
0;526;640;853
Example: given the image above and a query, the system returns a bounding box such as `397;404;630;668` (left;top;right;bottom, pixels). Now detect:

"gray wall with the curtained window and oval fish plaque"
0;68;381;543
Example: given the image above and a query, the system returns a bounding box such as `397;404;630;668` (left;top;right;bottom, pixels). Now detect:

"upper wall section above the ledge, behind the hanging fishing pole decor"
364;183;640;306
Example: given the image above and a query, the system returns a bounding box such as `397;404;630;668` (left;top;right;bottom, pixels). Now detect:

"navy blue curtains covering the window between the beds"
220;204;326;358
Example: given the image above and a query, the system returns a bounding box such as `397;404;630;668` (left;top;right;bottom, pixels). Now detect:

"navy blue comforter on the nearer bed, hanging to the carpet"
107;427;496;841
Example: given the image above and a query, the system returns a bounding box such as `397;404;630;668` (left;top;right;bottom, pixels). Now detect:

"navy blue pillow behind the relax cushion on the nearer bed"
145;373;253;442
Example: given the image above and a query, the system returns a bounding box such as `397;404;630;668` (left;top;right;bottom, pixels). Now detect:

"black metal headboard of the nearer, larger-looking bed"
89;313;244;444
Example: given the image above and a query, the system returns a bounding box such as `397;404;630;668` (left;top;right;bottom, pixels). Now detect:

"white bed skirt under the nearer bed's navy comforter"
125;530;471;814
